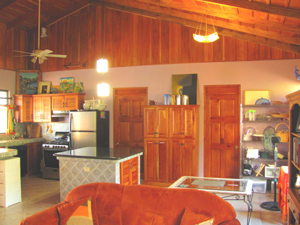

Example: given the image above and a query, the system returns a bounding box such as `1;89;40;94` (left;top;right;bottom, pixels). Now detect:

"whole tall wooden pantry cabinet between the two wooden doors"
144;105;199;186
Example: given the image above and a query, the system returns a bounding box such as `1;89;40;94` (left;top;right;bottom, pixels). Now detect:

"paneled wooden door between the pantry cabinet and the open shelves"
204;85;240;178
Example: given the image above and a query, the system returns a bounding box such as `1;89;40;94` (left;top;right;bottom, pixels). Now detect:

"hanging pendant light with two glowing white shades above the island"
96;1;109;96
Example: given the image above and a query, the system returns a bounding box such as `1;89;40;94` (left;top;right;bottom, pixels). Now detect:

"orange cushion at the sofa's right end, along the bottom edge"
180;208;214;225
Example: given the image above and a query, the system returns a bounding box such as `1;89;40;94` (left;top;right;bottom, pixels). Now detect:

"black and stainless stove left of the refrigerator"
41;131;69;180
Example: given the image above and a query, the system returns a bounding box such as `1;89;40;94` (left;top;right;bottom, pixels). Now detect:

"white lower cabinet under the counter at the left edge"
0;157;21;207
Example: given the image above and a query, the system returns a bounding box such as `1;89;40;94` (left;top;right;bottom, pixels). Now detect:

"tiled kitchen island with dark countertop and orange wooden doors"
54;147;143;201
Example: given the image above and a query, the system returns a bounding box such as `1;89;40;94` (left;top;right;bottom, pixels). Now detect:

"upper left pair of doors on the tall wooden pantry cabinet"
144;106;169;138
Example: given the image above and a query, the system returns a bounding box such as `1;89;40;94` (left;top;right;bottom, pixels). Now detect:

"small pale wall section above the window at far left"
0;69;16;104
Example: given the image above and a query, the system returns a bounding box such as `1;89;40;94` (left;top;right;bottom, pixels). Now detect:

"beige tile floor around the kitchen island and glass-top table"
0;176;287;225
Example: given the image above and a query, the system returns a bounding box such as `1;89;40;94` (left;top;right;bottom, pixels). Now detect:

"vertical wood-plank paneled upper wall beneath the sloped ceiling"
0;5;300;71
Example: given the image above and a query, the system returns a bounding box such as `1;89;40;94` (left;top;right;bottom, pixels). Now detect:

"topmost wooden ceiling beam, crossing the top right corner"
197;0;300;19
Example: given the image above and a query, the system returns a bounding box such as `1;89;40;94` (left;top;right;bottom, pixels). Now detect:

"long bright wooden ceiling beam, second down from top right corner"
101;0;300;34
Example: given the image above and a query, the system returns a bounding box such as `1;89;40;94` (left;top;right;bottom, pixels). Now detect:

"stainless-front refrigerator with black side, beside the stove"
70;110;109;150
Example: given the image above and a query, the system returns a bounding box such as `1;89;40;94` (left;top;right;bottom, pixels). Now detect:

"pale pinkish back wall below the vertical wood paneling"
42;59;300;175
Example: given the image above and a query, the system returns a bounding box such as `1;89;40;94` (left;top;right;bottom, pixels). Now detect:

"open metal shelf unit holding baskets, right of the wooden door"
240;104;289;179
